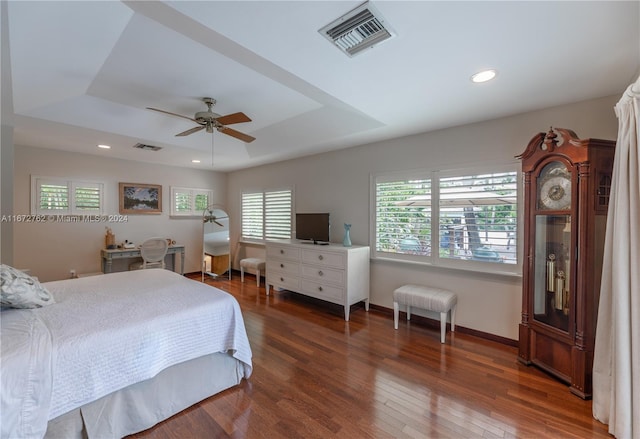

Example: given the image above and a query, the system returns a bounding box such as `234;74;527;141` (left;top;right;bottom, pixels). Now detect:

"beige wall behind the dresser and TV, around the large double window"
227;96;619;340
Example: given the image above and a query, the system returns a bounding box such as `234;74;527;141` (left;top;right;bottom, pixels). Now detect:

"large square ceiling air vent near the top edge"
318;2;394;57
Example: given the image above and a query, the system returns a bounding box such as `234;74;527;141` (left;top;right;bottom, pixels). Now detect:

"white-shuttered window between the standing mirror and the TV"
242;189;293;241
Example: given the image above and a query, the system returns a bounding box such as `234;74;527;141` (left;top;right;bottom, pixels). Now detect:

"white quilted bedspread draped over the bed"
1;269;252;437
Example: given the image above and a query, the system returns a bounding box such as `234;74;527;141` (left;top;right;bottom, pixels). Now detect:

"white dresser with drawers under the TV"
266;239;369;321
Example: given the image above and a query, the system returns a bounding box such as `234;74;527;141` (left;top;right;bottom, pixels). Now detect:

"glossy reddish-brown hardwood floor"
131;273;612;439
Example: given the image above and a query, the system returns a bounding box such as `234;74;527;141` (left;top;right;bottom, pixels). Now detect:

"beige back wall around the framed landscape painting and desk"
14;146;227;281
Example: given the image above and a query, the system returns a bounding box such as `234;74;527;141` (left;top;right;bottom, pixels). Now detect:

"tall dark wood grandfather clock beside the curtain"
518;128;615;399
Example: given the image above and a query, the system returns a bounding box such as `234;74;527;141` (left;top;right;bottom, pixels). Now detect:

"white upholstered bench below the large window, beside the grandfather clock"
393;285;458;343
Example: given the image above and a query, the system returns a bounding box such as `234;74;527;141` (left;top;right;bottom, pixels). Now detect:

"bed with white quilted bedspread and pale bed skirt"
0;269;252;438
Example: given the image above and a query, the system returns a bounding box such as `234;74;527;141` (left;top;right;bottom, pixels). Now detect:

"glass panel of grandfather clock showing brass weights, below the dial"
533;215;571;332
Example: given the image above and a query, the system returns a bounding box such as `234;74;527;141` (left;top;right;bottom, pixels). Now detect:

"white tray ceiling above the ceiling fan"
2;1;640;171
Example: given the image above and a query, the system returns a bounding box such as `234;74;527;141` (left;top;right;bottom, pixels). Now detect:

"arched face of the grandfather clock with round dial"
537;161;571;210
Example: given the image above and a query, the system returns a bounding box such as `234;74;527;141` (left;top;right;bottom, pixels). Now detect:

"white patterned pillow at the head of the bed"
0;264;55;308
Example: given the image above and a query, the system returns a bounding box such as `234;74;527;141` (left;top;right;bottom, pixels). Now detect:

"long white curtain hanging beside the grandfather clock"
593;78;640;439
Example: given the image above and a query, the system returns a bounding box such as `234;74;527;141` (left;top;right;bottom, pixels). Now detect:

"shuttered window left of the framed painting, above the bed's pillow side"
31;176;104;215
